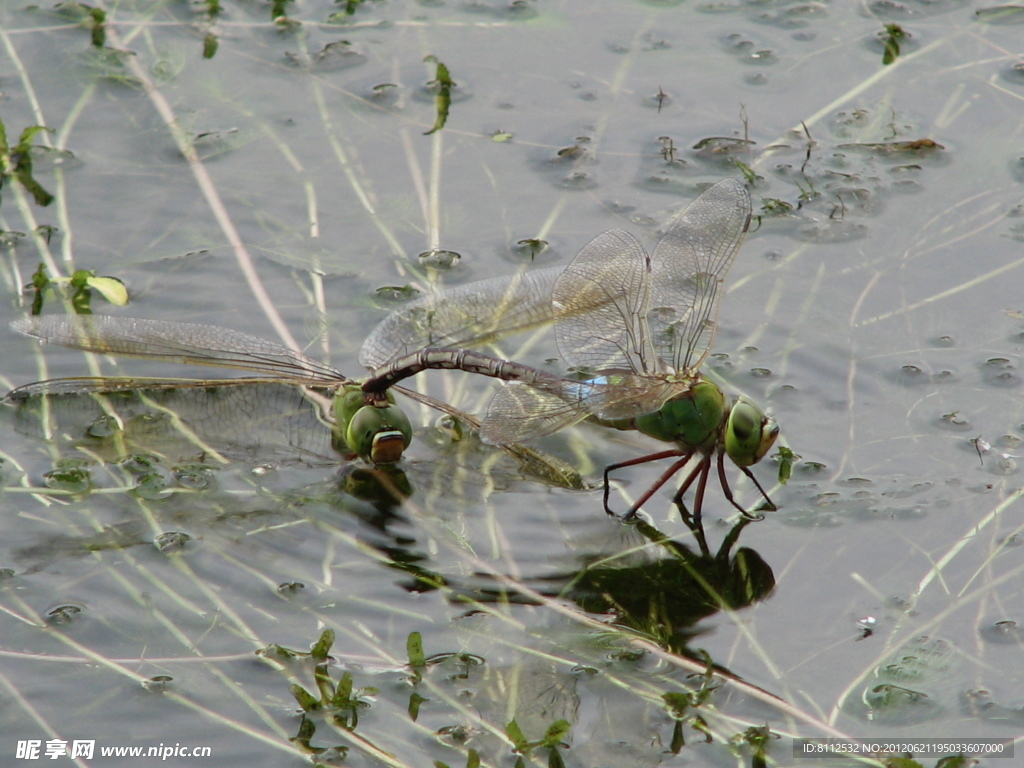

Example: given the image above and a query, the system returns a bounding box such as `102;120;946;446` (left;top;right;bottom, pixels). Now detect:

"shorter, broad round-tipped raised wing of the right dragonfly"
552;229;654;373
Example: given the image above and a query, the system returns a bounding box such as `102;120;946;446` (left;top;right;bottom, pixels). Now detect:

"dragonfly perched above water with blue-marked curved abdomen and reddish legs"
360;179;779;519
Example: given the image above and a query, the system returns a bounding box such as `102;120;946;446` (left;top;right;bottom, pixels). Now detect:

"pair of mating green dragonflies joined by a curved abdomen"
7;179;778;519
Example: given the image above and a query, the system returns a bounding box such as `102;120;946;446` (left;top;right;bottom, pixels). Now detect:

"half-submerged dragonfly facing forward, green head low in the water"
5;314;581;486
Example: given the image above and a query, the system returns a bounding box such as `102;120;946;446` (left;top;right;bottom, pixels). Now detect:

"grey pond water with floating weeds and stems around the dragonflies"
0;0;1024;768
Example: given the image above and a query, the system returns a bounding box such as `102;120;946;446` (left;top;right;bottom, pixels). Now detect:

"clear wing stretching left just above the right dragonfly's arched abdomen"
359;266;561;371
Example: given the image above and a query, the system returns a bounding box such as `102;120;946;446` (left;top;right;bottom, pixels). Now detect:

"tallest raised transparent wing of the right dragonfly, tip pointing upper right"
648;179;751;373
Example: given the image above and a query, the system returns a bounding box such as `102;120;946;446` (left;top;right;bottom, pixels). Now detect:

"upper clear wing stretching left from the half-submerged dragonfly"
11;314;344;384
